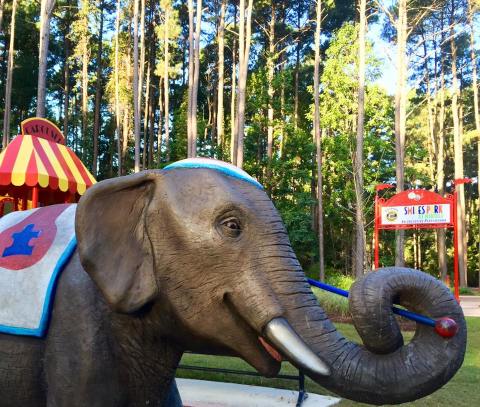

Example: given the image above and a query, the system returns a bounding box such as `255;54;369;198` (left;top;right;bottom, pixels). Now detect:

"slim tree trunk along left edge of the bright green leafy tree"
313;0;325;281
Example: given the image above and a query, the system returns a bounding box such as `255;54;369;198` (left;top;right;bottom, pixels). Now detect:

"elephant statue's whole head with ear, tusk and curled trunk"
76;160;466;404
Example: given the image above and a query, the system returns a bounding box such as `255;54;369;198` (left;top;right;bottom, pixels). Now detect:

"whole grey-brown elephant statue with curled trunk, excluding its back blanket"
0;159;466;407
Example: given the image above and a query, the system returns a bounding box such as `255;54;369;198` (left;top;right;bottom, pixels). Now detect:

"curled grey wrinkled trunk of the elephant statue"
274;266;466;404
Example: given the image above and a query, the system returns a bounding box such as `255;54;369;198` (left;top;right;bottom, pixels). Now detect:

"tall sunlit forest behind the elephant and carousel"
0;0;480;287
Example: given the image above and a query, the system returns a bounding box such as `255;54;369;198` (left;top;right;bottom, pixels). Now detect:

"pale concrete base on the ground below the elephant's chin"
176;379;340;407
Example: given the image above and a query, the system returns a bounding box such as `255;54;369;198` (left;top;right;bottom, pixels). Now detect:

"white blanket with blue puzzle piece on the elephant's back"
0;204;76;337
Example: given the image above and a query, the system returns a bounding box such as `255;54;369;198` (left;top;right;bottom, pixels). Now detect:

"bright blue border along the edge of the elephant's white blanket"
0;237;77;338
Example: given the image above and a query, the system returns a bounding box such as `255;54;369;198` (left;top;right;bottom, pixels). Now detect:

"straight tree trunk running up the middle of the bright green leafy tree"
353;0;367;277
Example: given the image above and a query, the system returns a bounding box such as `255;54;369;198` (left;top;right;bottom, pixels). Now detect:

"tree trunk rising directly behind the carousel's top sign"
37;0;55;117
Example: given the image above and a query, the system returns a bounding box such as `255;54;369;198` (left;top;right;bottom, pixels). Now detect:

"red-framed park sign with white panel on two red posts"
374;182;470;300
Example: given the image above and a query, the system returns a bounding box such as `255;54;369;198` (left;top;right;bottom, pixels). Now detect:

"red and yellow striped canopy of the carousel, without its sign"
0;135;96;195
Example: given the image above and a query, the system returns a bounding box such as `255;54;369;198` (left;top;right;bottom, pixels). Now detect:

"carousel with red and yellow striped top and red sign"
0;117;96;216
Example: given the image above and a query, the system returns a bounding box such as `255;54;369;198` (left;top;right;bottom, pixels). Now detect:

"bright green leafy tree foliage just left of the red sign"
310;23;394;272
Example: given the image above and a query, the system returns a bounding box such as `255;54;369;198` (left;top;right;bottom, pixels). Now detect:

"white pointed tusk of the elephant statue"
263;318;330;376
